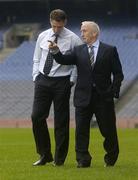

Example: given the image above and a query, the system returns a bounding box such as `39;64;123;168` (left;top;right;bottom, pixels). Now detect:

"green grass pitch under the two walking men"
0;128;138;180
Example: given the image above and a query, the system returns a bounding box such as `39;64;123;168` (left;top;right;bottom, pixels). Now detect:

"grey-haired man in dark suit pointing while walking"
49;21;123;168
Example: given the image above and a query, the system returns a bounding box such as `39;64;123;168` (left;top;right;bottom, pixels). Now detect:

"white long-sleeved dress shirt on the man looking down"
32;27;82;82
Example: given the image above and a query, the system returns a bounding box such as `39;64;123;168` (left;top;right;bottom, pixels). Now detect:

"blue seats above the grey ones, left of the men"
0;41;35;81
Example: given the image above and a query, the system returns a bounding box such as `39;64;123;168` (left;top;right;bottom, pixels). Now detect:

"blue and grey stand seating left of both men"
0;42;35;119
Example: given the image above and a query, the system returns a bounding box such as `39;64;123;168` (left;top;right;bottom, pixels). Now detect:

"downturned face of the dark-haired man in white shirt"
50;20;66;34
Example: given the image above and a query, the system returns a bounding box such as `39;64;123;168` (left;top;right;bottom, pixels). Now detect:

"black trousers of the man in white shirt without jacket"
32;74;71;163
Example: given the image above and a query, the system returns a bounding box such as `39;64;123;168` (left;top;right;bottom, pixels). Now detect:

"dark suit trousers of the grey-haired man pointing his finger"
75;90;119;165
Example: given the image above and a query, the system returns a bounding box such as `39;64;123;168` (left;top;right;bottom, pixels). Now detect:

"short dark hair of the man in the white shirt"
50;9;67;22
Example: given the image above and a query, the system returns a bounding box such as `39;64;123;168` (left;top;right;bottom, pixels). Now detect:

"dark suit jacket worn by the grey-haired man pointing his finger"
53;42;123;107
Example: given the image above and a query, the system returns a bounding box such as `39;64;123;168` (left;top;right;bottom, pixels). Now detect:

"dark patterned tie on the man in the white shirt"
44;34;58;75
